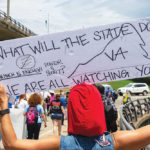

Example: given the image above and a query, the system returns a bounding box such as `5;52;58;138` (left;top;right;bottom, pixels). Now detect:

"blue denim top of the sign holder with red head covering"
60;132;114;150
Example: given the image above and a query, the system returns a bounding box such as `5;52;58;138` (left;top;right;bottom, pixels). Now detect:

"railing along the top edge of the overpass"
0;10;36;35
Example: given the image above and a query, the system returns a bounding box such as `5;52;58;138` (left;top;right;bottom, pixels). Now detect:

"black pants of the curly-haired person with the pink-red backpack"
27;123;41;139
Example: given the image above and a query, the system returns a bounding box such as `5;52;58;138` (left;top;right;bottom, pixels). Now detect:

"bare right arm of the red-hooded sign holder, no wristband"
113;125;150;150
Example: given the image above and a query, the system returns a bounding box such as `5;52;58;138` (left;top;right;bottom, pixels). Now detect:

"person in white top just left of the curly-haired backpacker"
15;94;28;109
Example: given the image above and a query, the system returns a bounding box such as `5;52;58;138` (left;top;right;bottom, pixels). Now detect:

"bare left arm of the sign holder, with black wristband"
0;84;60;150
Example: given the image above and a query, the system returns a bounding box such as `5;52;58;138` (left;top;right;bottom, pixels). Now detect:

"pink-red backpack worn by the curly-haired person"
26;106;38;124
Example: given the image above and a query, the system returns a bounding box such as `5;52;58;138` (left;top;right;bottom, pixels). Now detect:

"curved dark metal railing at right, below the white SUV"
120;97;150;150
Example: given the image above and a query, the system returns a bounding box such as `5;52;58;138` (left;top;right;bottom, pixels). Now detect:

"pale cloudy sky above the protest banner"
0;0;150;35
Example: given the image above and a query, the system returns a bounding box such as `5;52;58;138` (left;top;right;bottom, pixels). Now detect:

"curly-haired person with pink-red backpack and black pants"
24;93;47;139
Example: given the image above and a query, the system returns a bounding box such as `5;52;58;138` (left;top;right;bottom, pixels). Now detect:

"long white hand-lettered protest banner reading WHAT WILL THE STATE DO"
0;19;150;95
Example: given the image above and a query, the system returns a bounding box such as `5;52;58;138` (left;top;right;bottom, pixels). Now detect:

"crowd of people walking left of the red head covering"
8;90;66;139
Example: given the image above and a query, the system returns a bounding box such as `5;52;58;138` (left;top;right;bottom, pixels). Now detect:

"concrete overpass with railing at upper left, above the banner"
0;10;36;41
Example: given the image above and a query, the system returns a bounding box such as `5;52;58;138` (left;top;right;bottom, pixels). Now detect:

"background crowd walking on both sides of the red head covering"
3;84;136;139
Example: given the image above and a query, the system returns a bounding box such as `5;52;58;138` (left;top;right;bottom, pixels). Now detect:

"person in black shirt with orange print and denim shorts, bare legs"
50;94;65;135
